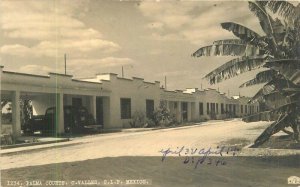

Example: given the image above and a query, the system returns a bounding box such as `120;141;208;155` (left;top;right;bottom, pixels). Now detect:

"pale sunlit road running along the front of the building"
1;120;268;169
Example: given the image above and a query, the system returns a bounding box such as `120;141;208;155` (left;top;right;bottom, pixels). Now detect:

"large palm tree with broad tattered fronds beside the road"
192;0;300;146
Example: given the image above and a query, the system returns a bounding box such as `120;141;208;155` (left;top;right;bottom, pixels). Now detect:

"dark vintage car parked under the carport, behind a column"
22;106;99;133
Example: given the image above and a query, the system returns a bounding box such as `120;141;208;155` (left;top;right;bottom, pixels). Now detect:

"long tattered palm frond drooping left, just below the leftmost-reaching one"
205;56;266;84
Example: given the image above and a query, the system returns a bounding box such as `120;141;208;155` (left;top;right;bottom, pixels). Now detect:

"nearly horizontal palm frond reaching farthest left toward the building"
192;39;247;57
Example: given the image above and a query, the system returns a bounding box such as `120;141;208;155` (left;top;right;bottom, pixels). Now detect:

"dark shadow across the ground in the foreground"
1;155;300;187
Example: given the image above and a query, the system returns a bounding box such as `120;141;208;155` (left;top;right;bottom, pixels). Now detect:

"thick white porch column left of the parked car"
12;91;21;138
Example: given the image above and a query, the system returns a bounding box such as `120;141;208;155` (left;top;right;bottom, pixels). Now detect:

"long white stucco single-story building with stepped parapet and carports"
0;66;259;137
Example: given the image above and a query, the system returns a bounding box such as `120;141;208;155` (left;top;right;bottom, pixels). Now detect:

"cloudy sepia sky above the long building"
0;0;274;96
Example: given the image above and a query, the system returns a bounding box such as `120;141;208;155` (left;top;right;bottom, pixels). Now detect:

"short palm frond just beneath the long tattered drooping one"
240;69;276;88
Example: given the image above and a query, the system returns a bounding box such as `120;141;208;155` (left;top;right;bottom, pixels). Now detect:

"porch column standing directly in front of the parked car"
56;93;65;134
